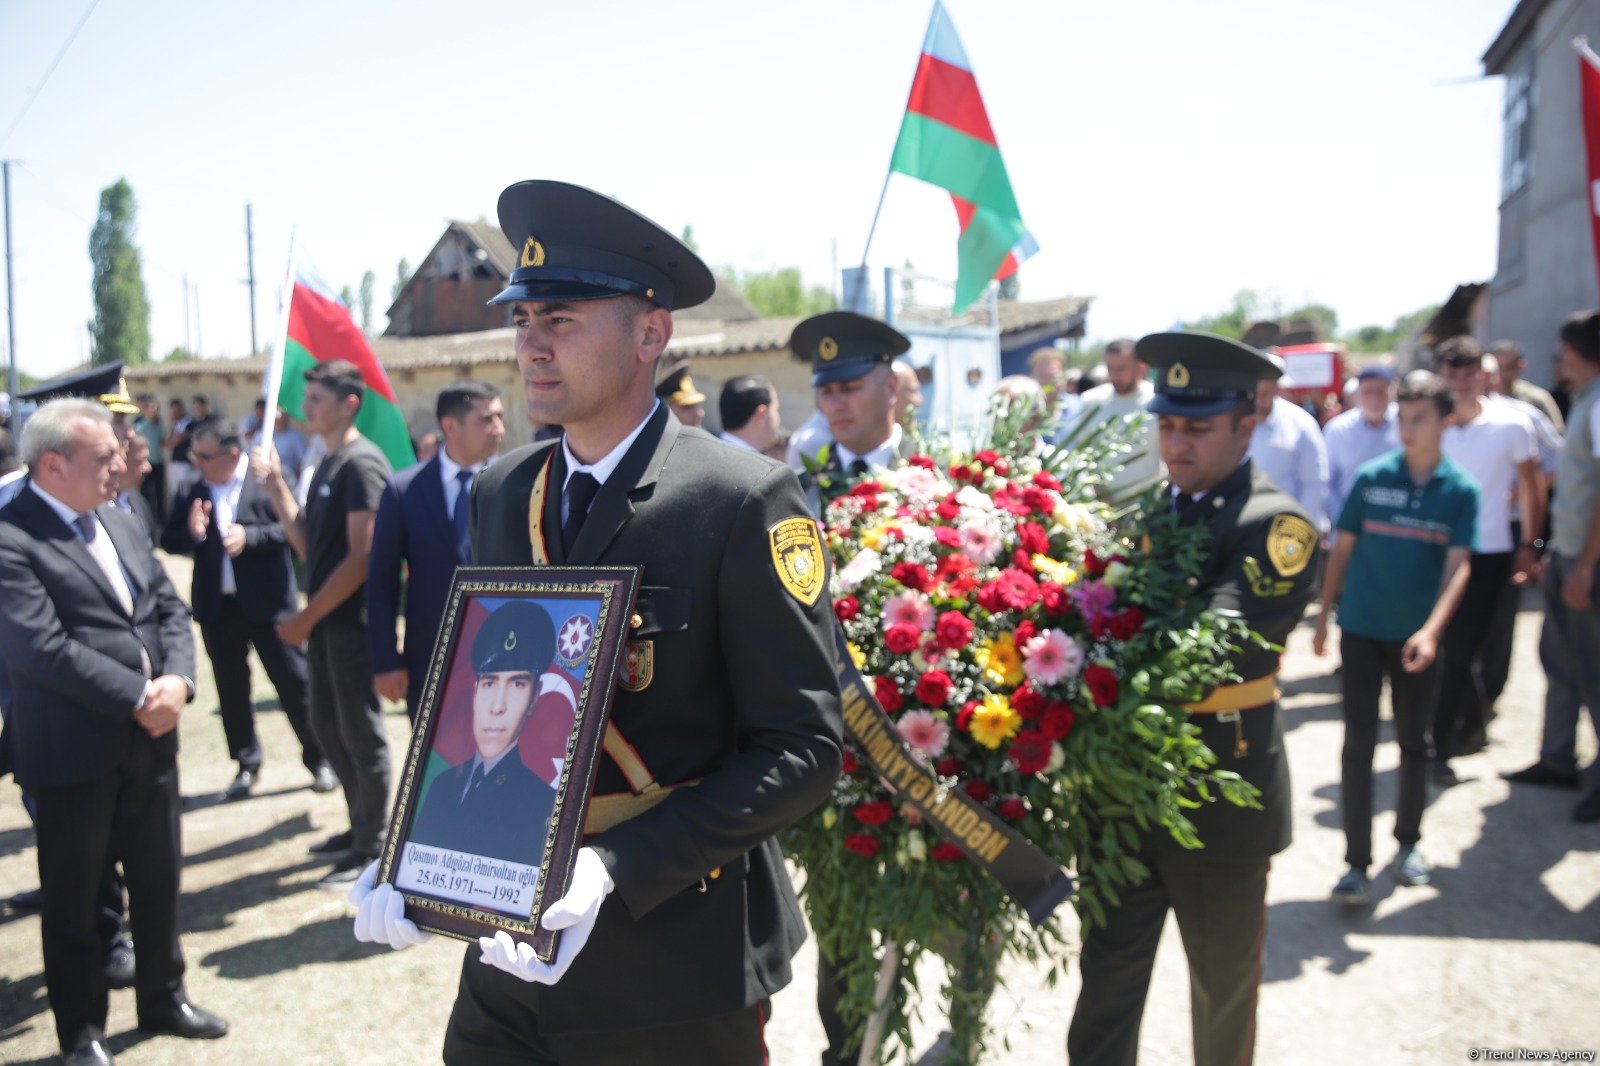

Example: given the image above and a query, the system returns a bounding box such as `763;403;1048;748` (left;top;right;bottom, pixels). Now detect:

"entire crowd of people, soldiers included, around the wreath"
0;182;1600;1063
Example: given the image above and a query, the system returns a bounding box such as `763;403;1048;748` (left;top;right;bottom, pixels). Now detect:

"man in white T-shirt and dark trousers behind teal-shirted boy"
1434;336;1544;784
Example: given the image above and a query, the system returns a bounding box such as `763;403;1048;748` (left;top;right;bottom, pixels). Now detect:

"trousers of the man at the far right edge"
1539;552;1600;787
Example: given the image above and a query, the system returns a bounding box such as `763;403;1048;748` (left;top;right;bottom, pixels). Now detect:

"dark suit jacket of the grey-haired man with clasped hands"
0;488;195;789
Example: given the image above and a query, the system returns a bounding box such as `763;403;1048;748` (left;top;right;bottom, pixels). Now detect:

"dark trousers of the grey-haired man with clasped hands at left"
34;730;186;1052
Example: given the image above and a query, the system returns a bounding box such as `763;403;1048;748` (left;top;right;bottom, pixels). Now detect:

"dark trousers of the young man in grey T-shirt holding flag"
309;619;392;858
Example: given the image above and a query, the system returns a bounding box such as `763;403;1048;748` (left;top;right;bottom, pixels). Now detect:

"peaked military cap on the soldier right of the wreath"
1134;330;1283;418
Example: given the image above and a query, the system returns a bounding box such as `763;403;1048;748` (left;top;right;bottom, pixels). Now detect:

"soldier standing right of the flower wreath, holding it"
1067;333;1318;1066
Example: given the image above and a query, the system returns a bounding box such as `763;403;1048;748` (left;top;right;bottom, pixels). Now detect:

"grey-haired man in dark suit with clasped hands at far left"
0;393;227;1063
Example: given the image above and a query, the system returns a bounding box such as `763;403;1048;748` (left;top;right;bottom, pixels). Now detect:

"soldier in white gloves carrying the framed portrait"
352;181;842;1066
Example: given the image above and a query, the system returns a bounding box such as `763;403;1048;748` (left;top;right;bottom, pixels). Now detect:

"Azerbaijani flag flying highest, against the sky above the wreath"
890;0;1038;314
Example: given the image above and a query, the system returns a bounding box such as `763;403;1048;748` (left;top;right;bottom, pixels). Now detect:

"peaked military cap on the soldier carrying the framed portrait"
490;181;717;311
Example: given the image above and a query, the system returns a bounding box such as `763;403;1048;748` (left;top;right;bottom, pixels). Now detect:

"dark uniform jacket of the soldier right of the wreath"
1157;461;1322;860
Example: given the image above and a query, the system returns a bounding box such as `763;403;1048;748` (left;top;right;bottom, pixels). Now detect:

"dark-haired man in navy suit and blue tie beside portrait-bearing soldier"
366;379;506;722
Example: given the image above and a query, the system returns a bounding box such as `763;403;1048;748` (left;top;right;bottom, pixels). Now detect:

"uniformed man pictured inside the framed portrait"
408;600;555;866
